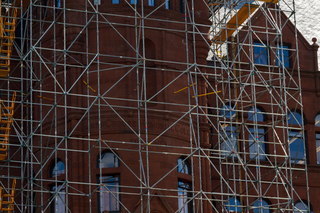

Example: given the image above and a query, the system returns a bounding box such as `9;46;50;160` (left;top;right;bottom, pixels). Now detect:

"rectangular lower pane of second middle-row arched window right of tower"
249;128;266;160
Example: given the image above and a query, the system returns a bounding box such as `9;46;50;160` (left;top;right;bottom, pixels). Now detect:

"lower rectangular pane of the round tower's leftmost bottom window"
50;185;67;213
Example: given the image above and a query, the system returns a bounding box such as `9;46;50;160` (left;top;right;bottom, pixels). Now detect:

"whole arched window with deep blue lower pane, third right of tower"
288;111;306;164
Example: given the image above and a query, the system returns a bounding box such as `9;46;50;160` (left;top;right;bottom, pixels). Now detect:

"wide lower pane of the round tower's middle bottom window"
98;175;120;212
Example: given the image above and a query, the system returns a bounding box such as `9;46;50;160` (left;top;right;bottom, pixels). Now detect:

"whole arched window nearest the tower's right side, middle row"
219;105;238;156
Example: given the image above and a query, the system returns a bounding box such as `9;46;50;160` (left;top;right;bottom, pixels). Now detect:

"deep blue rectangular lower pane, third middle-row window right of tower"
289;131;305;164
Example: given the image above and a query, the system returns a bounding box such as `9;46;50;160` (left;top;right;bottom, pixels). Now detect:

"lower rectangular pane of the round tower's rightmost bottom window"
178;180;192;213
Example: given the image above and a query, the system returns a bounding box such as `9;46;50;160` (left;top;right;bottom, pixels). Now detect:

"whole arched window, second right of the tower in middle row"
248;107;266;160
